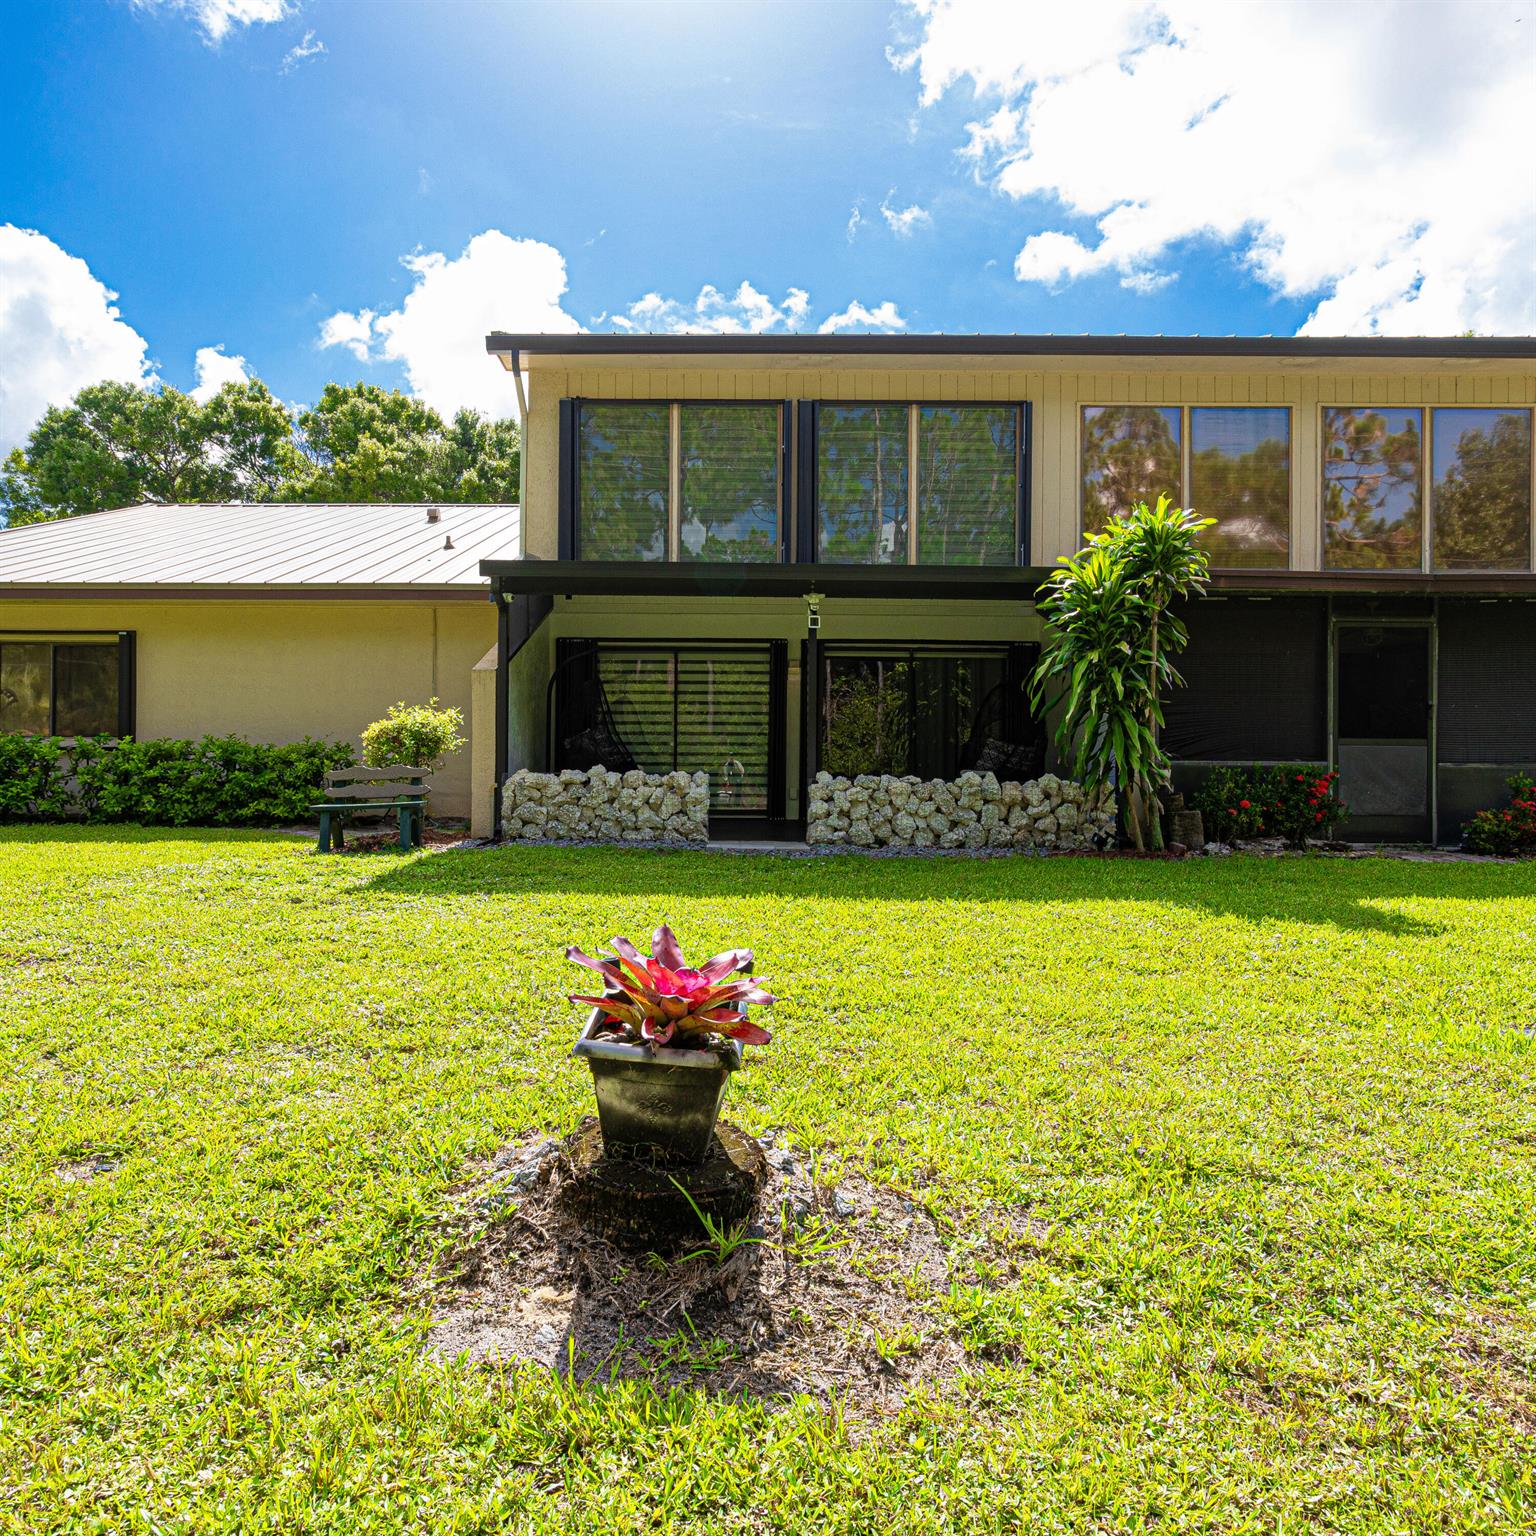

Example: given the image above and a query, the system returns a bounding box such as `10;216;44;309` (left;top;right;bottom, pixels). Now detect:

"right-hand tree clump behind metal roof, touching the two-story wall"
280;382;519;502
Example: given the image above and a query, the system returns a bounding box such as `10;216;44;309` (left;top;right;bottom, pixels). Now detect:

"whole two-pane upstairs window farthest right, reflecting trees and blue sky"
1322;406;1531;571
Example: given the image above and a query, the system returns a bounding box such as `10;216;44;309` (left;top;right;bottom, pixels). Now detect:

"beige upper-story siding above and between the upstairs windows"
522;355;1536;570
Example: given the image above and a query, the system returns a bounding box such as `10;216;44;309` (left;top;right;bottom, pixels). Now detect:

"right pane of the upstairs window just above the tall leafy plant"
1189;406;1290;568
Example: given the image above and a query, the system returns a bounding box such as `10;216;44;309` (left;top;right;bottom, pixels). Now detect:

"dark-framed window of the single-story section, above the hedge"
0;634;132;736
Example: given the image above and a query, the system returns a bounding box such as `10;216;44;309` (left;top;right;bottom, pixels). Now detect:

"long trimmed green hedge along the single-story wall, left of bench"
0;734;355;826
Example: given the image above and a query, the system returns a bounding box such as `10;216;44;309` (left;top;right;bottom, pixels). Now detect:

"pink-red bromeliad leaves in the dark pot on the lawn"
565;923;773;1049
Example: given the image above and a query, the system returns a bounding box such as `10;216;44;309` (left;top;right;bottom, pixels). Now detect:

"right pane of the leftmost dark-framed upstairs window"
679;406;779;561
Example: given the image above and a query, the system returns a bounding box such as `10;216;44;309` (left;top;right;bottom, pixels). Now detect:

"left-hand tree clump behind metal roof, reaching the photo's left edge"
0;379;298;525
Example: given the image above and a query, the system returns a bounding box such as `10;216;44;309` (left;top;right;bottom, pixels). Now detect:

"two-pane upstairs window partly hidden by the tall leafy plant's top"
1081;406;1290;570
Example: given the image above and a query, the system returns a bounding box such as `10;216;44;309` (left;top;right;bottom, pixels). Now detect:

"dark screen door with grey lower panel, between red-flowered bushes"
1333;622;1435;842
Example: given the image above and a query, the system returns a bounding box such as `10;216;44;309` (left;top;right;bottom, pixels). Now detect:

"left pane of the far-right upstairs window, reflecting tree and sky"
1322;406;1424;570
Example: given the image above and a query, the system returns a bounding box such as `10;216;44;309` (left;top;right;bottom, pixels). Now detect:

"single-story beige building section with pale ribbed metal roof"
0;504;519;829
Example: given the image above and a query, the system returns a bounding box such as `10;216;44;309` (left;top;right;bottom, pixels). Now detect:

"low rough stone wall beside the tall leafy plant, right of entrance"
805;773;1115;849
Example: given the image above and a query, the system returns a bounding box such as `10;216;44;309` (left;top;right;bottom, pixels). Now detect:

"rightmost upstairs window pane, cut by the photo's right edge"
1432;410;1531;570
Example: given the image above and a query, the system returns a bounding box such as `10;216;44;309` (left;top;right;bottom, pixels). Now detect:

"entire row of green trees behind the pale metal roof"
0;379;519;524
